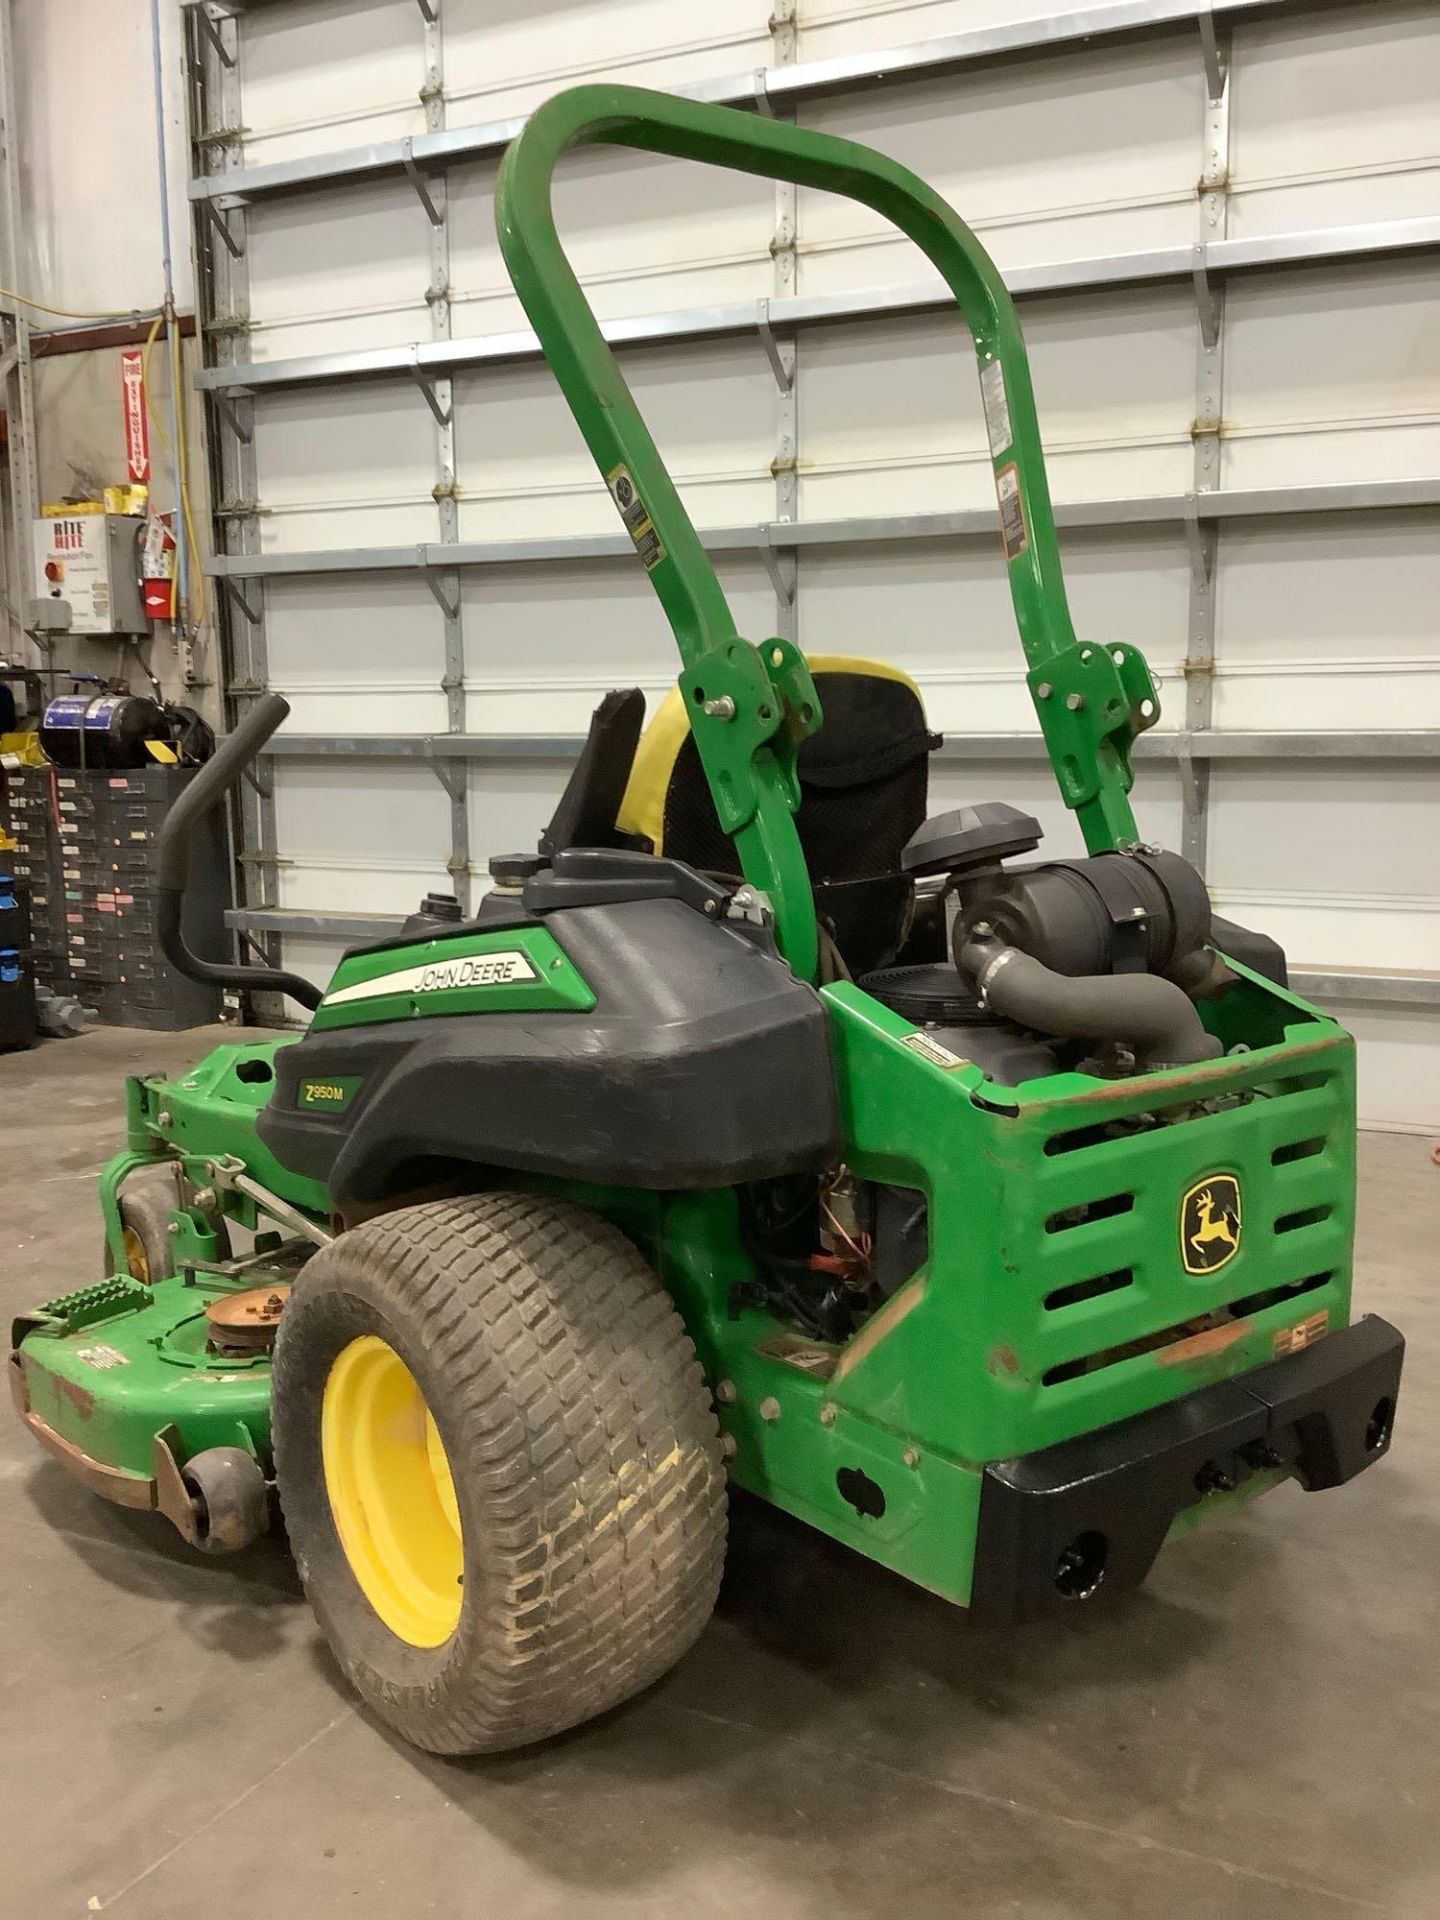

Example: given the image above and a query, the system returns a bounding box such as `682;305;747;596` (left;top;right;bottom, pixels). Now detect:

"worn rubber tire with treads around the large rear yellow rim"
275;1192;726;1753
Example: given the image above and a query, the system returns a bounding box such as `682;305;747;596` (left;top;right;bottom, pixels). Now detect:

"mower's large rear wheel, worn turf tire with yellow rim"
273;1194;726;1753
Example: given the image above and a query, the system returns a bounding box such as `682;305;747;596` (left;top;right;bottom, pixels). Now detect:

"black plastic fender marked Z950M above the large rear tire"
257;899;841;1212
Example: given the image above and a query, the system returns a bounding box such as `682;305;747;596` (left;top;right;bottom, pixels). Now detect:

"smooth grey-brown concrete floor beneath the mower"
0;1031;1440;1920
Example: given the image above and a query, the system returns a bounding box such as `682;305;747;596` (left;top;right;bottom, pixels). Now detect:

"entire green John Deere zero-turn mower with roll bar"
12;86;1402;1753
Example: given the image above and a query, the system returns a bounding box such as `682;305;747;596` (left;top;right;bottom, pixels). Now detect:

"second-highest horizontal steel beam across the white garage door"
198;215;1440;394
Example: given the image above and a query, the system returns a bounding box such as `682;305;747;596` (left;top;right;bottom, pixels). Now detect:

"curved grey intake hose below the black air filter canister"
960;939;1223;1069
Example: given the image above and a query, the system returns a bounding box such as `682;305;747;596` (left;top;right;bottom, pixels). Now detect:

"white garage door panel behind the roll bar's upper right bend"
799;38;1202;294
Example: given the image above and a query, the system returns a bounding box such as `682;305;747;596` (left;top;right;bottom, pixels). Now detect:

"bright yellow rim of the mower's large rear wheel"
321;1332;465;1647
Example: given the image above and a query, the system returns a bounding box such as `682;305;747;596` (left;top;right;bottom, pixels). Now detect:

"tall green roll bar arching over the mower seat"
495;84;1160;979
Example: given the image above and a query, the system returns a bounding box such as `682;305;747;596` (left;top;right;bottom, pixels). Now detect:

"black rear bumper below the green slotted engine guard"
970;1317;1405;1622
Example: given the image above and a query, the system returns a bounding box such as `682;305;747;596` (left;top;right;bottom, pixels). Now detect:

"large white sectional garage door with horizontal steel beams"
192;0;1440;1127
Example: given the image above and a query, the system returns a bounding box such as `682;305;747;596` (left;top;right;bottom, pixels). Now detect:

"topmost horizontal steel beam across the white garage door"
190;0;1305;200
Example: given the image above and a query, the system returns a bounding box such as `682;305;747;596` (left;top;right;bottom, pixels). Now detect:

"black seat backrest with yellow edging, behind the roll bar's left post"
618;655;939;972
